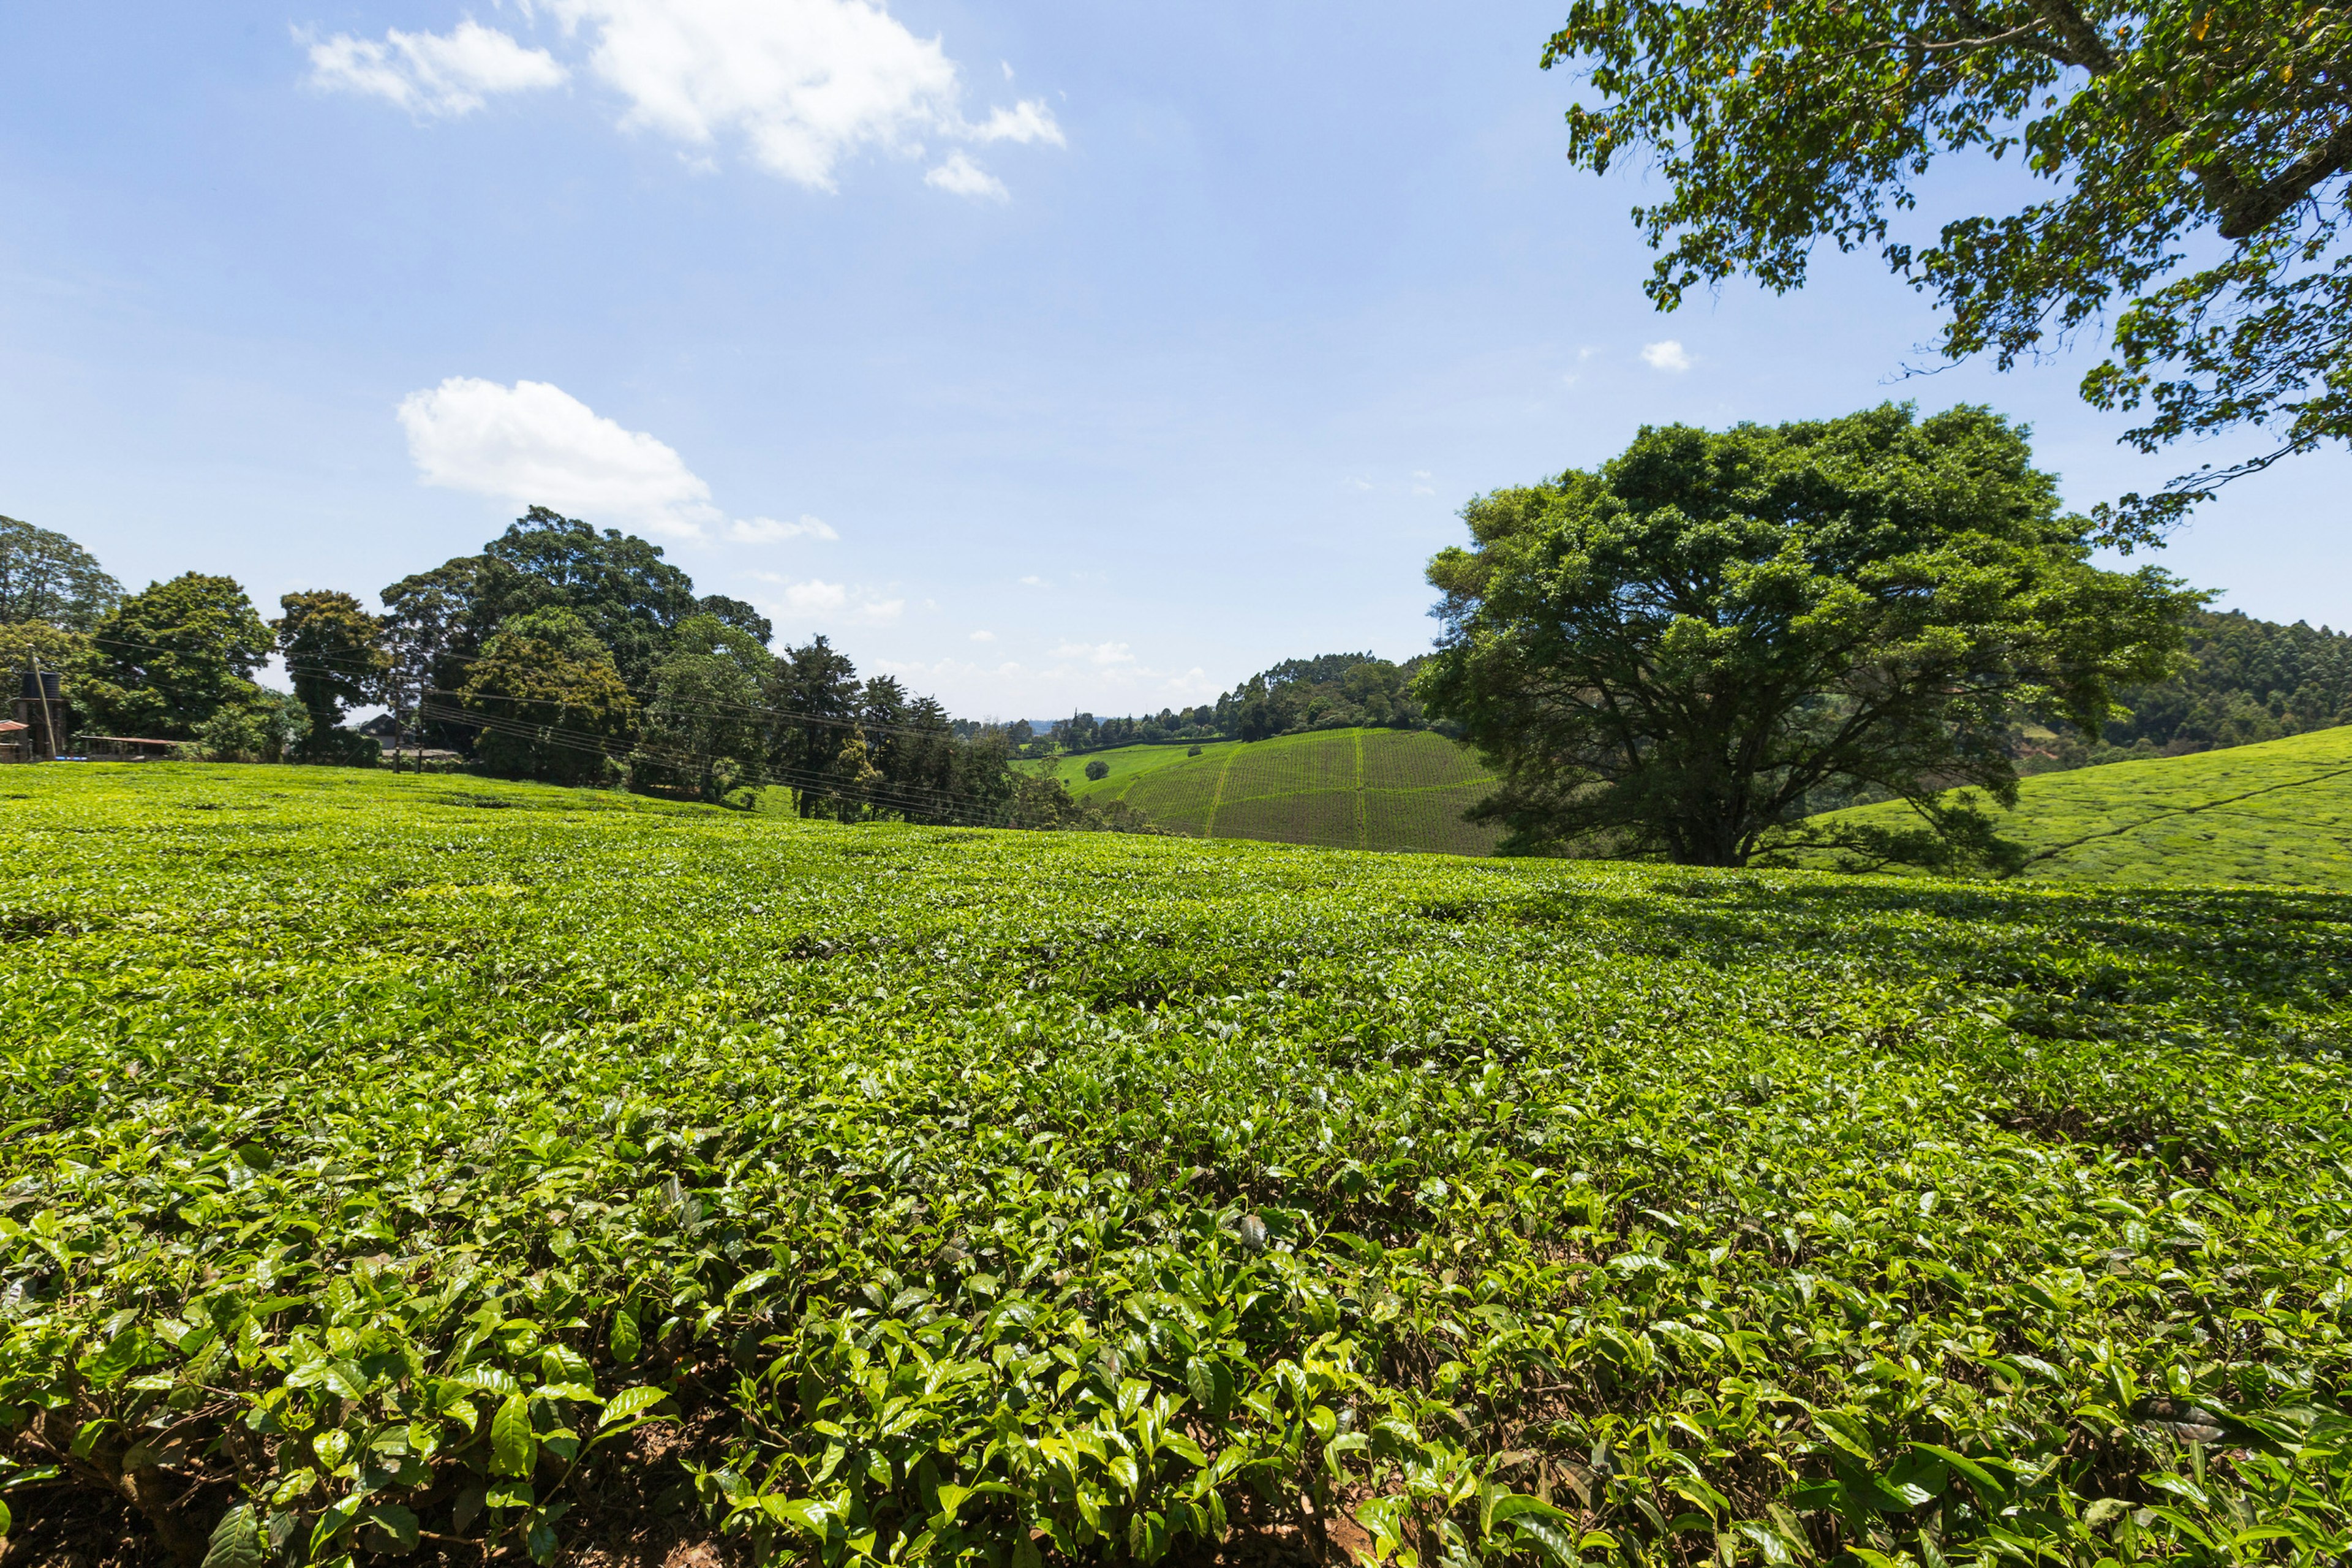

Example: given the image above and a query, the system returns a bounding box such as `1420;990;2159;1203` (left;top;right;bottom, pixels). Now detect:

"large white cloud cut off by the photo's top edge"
541;0;1063;195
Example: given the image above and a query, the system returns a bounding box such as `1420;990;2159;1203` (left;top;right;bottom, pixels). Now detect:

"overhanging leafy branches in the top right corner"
1543;0;2352;545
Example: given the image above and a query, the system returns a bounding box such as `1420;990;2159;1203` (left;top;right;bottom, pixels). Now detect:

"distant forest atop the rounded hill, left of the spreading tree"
1051;654;1430;752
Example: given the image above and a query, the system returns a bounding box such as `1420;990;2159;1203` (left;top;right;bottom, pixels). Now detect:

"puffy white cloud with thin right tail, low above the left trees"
400;376;835;543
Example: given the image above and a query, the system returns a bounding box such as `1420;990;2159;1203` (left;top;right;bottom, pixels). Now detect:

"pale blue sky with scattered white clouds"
0;0;2352;717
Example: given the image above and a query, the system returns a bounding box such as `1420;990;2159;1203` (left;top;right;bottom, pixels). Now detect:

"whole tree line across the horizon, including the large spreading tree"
0;404;2352;870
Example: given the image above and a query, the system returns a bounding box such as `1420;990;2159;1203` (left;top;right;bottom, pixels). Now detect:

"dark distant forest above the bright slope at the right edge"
2021;609;2352;771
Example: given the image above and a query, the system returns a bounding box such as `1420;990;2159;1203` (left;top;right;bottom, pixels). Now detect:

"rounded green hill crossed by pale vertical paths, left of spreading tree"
1049;729;1503;856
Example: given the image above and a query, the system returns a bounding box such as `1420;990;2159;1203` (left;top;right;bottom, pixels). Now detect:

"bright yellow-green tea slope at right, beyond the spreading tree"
1825;729;2352;889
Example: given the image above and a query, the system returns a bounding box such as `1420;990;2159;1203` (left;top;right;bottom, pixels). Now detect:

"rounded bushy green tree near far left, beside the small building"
70;571;275;741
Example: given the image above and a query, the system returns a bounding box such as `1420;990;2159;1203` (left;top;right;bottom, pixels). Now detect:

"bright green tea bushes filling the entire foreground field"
0;764;2352;1568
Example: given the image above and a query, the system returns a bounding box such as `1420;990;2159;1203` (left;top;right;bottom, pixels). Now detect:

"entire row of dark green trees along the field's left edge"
0;508;1140;827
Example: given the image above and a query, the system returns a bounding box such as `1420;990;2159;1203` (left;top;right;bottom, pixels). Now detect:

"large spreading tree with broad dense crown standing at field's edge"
1419;404;2199;865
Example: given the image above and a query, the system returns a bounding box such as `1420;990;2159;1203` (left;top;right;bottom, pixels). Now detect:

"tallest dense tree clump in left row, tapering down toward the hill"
383;508;1105;827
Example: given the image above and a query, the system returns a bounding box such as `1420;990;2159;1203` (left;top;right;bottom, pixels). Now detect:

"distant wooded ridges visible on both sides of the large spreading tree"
1058;609;2352;774
